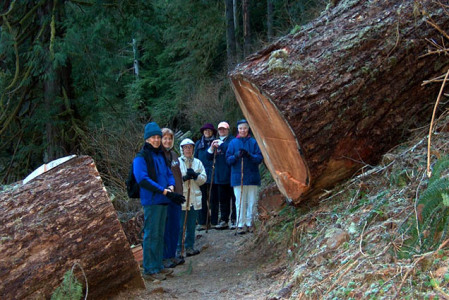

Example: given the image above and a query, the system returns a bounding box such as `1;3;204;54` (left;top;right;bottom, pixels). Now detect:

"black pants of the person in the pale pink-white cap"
211;184;235;223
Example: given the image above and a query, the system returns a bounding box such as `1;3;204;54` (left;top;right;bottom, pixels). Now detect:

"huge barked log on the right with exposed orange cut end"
230;0;449;204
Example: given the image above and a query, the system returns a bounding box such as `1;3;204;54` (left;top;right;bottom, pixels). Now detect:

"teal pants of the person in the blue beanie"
142;205;168;274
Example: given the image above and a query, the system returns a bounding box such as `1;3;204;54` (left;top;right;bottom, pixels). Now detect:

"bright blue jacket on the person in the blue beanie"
133;143;175;205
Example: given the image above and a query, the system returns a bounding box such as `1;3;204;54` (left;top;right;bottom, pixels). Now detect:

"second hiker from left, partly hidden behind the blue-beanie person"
161;128;185;268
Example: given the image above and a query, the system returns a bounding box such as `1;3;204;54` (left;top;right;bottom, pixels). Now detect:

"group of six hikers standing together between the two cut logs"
133;119;263;280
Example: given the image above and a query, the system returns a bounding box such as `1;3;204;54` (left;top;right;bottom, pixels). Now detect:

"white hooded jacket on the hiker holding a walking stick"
179;155;206;210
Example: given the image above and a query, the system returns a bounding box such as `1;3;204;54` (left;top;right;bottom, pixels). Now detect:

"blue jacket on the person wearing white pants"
226;136;263;186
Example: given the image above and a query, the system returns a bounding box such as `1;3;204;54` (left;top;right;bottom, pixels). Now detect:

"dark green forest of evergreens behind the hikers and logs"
0;0;331;188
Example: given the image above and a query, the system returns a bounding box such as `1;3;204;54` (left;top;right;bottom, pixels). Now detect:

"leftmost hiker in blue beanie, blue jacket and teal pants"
133;122;183;280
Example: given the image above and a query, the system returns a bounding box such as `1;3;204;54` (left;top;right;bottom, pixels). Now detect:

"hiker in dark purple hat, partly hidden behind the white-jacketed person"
194;123;217;230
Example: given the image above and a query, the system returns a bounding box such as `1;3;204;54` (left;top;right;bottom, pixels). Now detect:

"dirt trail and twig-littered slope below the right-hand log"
114;115;449;300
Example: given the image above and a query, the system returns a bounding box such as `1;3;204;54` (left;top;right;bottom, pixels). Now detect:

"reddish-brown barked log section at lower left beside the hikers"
0;156;144;299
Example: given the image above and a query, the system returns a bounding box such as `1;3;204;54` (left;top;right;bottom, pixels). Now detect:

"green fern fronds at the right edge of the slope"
403;157;449;253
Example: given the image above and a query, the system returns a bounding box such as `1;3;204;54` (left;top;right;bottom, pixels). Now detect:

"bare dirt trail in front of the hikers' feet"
113;230;280;300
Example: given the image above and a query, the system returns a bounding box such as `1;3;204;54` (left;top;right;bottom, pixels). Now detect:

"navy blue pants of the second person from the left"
163;202;182;259
